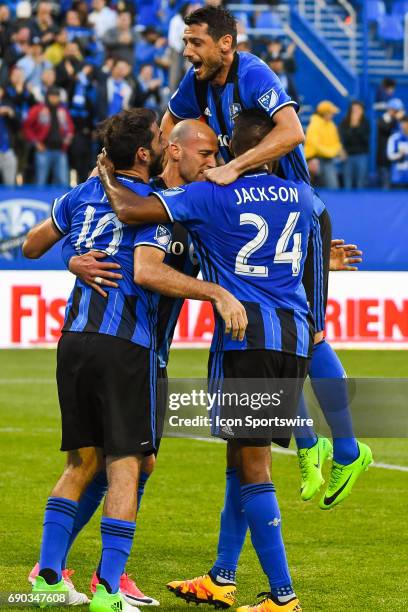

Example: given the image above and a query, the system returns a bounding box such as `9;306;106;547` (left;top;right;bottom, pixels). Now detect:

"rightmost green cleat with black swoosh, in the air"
319;442;373;510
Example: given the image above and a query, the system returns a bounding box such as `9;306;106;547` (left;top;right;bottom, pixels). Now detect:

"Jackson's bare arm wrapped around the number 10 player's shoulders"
98;153;169;225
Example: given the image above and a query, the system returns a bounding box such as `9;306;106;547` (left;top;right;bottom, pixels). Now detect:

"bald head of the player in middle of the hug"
168;119;218;183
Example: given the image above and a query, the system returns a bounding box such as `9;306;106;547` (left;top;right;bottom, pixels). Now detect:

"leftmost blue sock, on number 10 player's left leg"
40;497;78;583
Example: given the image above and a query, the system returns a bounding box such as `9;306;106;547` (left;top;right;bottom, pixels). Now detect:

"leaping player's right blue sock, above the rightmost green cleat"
309;340;359;465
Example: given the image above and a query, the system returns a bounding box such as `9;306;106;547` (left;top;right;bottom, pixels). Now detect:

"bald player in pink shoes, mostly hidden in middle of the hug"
29;120;218;606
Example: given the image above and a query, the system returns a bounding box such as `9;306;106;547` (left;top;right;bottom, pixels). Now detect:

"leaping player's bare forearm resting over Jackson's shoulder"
205;106;305;185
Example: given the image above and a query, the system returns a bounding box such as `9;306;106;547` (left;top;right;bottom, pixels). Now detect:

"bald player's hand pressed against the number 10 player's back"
69;251;122;298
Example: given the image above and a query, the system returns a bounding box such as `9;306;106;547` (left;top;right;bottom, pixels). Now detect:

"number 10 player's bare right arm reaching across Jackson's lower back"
134;246;248;341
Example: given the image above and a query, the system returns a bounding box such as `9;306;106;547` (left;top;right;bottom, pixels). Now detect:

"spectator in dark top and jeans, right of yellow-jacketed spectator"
340;100;370;189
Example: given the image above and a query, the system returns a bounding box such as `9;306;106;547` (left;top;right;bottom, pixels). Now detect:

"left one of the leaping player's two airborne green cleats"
298;438;333;501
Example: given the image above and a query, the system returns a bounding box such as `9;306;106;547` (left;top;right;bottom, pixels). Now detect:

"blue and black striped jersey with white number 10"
52;176;171;349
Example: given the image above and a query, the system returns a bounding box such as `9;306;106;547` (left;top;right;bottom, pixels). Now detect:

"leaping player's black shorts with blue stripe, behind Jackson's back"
303;209;332;332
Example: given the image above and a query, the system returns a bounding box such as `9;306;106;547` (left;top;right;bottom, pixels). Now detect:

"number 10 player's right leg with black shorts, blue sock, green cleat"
91;338;161;612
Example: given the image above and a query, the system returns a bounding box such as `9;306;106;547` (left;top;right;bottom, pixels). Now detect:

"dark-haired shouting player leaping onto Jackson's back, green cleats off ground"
161;6;372;510
